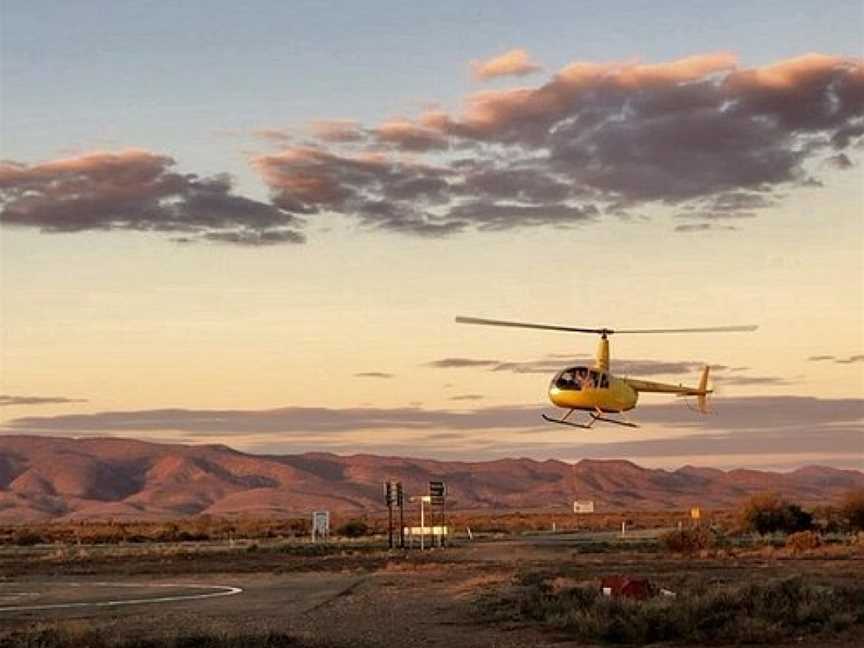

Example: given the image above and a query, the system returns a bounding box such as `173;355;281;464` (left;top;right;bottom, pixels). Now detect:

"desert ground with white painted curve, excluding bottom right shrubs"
0;531;864;648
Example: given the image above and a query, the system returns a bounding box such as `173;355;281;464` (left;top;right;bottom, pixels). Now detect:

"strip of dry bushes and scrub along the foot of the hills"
0;489;864;546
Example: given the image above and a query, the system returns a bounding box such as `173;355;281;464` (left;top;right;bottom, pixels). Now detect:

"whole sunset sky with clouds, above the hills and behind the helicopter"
0;0;864;470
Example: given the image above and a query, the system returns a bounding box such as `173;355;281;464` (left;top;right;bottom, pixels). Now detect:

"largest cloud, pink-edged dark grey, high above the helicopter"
252;52;864;237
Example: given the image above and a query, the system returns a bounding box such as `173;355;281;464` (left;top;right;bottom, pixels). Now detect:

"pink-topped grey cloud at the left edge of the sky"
0;149;304;245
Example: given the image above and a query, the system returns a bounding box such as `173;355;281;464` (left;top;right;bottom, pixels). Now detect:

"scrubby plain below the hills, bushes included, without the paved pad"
0;492;864;648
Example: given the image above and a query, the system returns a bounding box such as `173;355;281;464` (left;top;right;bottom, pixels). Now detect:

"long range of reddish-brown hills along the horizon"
0;435;864;522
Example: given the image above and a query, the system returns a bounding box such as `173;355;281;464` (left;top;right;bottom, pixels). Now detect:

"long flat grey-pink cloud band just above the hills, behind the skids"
4;396;864;465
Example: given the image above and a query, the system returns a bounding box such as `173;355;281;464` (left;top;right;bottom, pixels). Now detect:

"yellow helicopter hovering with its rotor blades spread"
456;317;758;429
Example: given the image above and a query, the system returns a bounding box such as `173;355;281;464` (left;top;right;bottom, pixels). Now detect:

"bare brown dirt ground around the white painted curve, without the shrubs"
0;535;864;648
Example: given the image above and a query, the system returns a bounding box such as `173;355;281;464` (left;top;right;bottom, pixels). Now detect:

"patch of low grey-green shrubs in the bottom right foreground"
484;578;864;644
